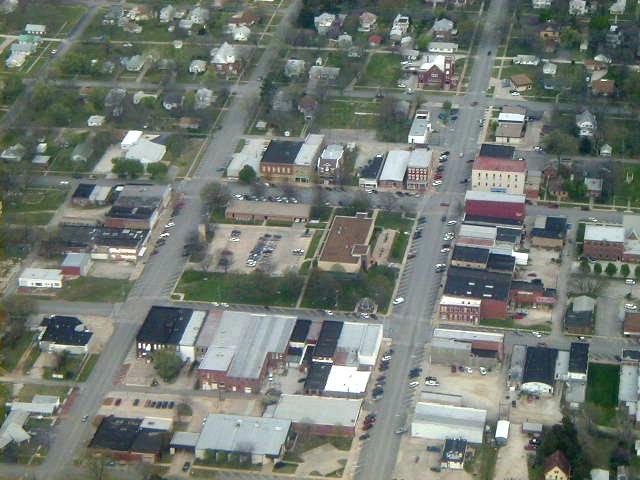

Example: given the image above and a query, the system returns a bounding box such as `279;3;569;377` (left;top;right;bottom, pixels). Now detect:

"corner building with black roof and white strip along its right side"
136;306;207;363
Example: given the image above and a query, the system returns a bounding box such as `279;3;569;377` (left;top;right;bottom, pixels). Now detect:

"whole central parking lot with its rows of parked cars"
208;224;313;274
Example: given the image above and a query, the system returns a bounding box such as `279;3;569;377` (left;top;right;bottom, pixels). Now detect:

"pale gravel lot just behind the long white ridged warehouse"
423;365;505;421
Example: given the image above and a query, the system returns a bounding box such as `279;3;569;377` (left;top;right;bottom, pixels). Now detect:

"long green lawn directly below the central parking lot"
175;270;302;307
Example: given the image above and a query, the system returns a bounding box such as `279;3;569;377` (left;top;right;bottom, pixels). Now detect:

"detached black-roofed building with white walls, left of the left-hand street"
38;315;93;355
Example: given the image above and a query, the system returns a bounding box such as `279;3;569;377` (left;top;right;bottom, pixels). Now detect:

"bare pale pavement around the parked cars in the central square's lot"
209;224;312;274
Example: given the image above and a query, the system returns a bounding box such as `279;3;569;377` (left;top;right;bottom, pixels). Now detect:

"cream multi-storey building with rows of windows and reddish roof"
471;155;527;194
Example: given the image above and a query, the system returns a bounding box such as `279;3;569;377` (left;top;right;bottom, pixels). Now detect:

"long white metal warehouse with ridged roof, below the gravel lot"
411;402;487;443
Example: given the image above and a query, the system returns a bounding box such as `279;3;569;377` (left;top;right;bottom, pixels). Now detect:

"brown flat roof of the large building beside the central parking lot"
320;216;374;264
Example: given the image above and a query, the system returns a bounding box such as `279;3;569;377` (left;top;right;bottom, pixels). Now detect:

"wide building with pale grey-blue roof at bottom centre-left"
195;413;291;464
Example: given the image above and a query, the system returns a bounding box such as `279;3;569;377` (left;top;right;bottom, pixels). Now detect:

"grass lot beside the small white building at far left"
58;277;133;303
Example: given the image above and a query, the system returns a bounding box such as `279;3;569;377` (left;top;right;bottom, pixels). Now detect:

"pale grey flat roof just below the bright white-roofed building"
273;395;362;427
